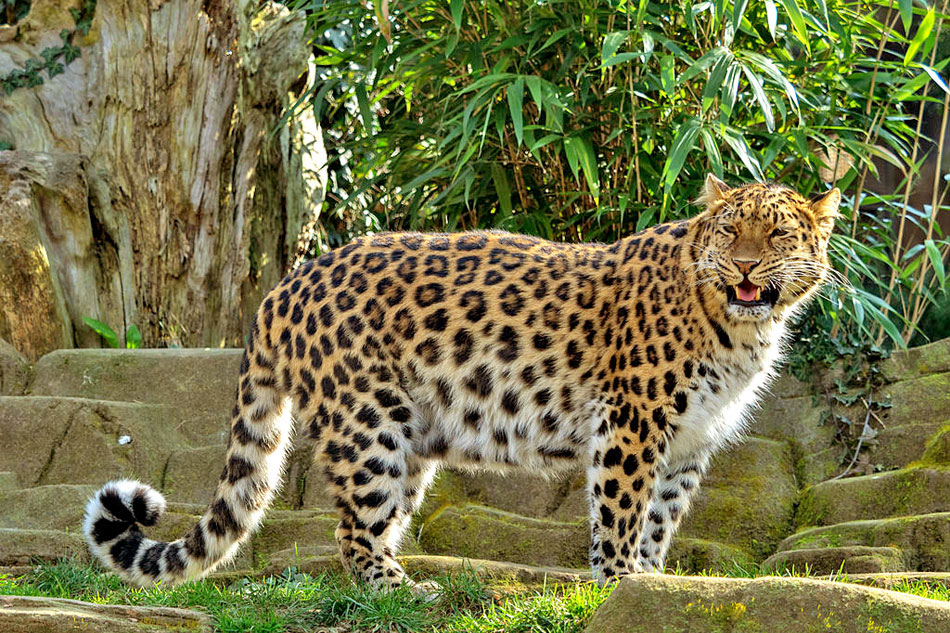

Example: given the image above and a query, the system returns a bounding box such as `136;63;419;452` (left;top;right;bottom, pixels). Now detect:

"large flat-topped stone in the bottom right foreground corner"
585;574;950;633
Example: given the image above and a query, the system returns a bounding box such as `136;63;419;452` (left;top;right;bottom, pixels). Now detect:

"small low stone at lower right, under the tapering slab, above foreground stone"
761;545;905;574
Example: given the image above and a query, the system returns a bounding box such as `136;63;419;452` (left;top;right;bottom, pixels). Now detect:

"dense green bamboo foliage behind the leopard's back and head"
292;0;950;345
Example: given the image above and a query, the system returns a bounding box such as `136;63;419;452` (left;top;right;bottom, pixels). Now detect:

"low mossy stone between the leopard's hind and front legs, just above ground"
419;505;590;569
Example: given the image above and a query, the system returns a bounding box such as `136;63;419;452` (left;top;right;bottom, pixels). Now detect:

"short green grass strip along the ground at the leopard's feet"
0;561;950;633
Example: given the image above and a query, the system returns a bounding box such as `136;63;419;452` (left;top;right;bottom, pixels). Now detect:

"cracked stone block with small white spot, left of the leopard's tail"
0;396;186;487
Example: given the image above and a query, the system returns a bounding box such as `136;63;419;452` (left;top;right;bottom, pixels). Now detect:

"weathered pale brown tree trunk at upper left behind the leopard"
0;0;325;357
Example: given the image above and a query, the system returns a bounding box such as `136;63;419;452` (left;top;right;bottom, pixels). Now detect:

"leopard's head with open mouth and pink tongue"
692;174;841;322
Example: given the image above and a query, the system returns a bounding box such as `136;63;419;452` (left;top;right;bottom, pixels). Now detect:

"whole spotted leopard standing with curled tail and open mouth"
84;176;840;588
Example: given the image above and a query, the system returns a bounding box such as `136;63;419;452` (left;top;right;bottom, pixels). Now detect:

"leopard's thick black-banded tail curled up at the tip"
83;328;293;586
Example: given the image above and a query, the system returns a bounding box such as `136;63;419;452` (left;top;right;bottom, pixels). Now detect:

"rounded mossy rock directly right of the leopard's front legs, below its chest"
679;438;798;560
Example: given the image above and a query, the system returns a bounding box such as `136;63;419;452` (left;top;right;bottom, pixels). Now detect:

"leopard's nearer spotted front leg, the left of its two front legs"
587;403;666;584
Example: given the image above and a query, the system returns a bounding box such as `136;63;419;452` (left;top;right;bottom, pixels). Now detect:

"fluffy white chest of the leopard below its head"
667;345;779;461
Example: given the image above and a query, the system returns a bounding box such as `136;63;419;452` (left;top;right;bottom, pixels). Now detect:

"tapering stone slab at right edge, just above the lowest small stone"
778;512;950;571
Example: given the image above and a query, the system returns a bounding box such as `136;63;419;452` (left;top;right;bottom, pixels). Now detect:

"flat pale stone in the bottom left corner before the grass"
0;596;213;633
